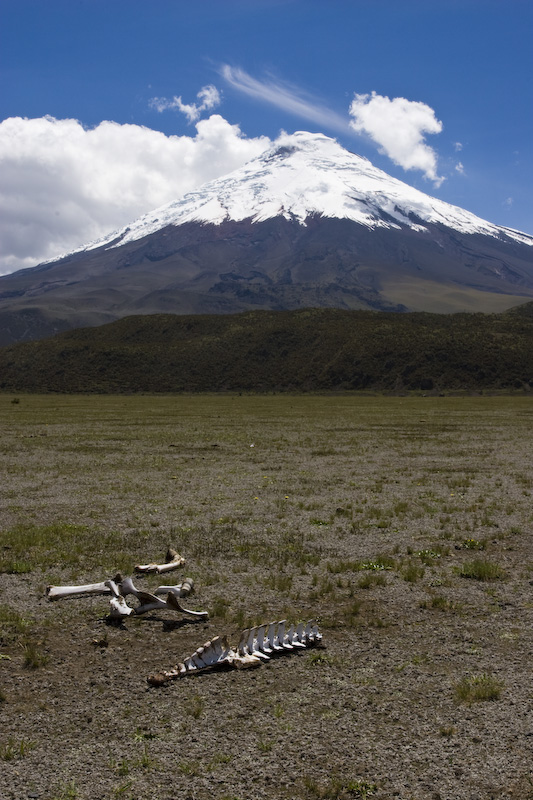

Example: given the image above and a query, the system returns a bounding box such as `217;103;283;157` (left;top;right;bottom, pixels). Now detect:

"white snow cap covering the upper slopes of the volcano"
64;131;533;250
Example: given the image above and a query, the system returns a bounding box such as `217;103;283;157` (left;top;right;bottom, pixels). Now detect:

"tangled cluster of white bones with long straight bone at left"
46;573;208;619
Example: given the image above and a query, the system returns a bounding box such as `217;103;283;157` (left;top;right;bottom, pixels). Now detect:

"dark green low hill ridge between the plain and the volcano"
0;303;533;393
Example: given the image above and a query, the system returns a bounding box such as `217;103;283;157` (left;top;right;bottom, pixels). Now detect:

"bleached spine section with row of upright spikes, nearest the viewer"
147;620;322;686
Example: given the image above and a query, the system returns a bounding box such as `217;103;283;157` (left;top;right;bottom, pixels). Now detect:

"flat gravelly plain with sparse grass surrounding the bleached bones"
0;395;533;800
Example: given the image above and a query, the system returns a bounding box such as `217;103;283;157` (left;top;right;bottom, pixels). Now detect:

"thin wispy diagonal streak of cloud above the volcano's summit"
220;64;350;133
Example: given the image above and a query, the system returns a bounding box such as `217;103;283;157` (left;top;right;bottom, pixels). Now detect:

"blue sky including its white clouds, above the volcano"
0;0;533;273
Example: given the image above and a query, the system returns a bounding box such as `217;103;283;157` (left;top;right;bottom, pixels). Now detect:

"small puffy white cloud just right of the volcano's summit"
350;92;444;186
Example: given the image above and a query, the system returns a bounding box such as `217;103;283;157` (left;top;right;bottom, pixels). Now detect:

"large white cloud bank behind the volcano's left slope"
0;114;271;274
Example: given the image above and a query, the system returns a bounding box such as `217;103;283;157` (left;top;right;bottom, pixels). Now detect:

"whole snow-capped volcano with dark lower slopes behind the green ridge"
0;132;533;343
